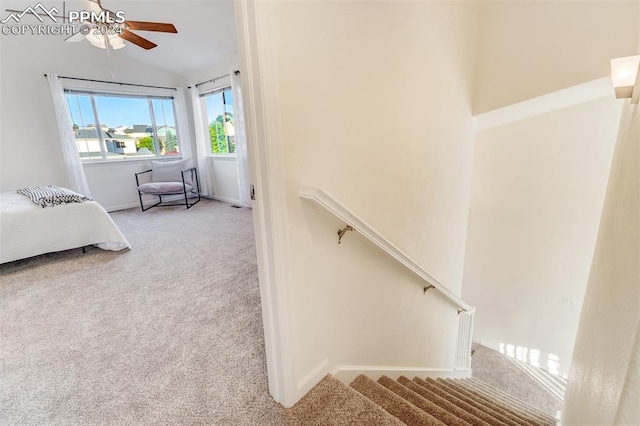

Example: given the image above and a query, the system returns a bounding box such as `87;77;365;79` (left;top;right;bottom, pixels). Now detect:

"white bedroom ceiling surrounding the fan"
10;0;237;77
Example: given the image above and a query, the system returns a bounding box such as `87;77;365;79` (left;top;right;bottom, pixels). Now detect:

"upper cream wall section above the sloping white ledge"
473;0;640;114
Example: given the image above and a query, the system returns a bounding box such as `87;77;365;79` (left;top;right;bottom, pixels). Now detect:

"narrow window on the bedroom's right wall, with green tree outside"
200;87;236;155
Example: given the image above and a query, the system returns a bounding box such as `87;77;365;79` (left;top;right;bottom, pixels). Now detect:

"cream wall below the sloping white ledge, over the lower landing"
463;96;621;374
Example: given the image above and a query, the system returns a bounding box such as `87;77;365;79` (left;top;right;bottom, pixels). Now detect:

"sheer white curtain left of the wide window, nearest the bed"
47;74;91;197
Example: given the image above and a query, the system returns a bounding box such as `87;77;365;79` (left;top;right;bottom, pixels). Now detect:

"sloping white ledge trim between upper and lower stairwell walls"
473;77;613;132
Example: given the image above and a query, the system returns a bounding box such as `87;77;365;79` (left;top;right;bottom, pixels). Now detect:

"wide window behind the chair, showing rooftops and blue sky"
65;90;180;160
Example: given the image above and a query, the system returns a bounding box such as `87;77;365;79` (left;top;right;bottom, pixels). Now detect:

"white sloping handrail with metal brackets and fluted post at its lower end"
299;187;476;370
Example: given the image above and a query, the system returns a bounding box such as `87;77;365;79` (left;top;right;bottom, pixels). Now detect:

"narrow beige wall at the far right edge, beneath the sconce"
562;100;640;425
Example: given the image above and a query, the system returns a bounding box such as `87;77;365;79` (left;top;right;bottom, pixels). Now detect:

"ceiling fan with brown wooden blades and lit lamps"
65;0;178;50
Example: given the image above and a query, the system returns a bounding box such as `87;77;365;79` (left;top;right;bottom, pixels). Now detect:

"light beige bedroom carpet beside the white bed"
0;200;286;425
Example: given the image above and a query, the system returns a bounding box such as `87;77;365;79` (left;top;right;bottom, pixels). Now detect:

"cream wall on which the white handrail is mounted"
258;2;479;404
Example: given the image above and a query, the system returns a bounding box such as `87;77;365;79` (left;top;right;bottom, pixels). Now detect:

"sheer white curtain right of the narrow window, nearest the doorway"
231;71;251;207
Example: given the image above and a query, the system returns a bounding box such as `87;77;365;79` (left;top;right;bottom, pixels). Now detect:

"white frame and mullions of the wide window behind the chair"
64;86;184;165
